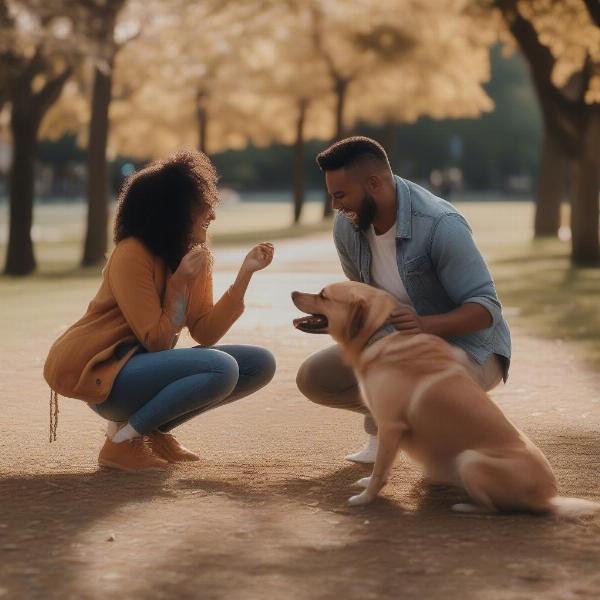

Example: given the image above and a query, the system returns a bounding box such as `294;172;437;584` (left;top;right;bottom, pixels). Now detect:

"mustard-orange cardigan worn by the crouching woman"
44;237;244;404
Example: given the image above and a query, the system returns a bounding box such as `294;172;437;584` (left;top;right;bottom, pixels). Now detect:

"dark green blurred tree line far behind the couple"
12;46;542;196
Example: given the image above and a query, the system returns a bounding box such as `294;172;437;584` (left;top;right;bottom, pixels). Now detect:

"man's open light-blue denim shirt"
333;176;511;381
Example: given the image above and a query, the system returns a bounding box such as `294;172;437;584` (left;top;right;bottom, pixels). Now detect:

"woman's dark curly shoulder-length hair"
114;151;218;271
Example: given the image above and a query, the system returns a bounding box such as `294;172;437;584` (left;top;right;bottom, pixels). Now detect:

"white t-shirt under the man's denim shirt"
367;223;412;306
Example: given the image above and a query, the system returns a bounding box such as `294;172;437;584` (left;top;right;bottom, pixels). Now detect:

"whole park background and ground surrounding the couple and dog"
0;0;600;599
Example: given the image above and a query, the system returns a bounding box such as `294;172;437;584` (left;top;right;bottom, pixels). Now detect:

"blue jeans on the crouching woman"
90;345;275;434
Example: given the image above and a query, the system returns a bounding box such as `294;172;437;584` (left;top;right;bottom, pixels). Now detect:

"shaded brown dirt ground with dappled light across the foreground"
0;430;600;600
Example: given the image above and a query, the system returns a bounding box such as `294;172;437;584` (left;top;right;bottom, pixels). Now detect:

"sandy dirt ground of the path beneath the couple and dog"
0;205;600;600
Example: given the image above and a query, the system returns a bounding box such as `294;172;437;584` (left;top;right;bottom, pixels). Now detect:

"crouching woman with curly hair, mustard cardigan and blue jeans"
44;152;275;471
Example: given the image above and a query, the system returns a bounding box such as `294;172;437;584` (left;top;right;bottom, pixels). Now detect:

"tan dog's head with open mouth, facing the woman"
292;281;397;355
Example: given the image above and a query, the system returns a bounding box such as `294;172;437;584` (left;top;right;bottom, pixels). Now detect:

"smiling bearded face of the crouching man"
325;169;377;231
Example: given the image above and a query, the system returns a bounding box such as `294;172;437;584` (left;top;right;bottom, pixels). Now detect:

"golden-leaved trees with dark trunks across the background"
0;0;600;275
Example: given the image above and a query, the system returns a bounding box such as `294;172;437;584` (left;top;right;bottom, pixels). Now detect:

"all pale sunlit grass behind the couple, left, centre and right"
0;202;600;367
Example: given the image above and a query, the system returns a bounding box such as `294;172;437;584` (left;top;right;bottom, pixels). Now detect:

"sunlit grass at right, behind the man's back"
454;204;600;368
